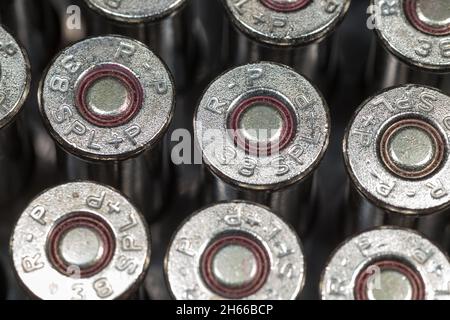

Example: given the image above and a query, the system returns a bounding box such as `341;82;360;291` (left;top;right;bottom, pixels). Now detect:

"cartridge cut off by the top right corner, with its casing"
367;0;450;94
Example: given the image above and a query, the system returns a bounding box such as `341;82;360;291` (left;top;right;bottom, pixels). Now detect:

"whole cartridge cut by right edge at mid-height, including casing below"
343;85;450;241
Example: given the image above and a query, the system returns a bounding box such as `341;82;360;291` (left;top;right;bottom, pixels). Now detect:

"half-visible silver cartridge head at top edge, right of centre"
223;0;350;46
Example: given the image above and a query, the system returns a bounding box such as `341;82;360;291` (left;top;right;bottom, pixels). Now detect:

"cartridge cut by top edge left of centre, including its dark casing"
85;0;223;91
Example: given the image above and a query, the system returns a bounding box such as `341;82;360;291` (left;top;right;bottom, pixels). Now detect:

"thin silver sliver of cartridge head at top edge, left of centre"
85;0;187;24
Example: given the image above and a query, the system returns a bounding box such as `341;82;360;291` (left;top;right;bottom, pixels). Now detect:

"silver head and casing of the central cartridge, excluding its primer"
194;62;329;229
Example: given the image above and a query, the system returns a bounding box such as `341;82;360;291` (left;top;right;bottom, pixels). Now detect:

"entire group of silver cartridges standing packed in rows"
0;0;450;300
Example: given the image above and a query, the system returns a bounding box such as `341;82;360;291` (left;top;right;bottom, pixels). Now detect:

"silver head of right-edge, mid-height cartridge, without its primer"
343;85;450;215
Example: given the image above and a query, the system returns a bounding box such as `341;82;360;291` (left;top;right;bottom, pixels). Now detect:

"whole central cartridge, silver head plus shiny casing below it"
194;62;330;231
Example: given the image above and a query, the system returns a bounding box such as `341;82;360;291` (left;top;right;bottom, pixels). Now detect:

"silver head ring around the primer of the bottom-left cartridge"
10;182;150;300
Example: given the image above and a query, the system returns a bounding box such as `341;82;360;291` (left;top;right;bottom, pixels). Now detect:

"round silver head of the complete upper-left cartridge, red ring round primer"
39;36;175;160
